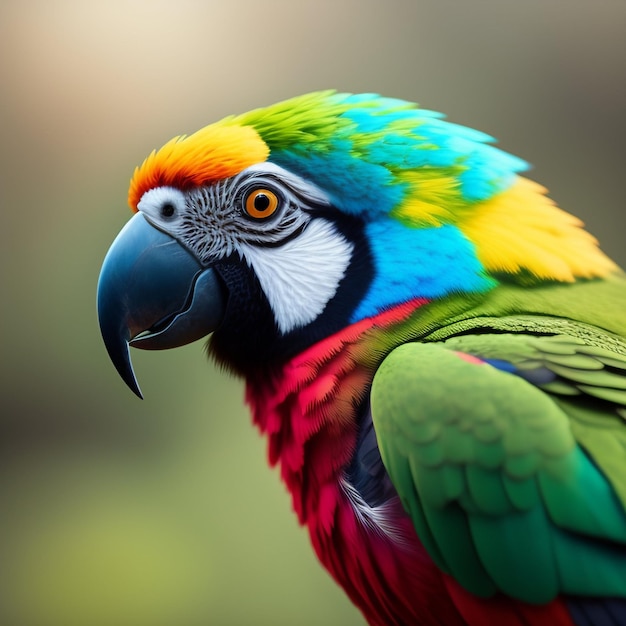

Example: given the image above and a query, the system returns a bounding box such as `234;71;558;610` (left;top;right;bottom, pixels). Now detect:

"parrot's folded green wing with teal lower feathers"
371;330;626;604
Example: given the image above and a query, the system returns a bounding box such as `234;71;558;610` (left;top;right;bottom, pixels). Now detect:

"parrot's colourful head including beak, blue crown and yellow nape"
98;91;613;395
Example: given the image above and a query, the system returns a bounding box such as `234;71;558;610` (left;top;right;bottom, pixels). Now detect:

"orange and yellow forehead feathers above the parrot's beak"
128;122;269;211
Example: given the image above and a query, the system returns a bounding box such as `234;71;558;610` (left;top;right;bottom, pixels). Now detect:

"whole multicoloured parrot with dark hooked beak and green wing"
97;90;626;626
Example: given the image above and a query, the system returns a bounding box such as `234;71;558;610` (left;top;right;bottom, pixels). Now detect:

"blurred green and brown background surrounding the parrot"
0;0;626;626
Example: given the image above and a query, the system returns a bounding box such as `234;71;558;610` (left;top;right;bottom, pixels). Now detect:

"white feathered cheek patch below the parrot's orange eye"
241;218;353;333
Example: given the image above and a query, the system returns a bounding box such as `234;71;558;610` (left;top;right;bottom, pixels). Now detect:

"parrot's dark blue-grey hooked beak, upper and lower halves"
98;213;225;398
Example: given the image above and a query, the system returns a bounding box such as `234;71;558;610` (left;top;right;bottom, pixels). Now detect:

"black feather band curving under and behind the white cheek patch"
208;212;373;377
